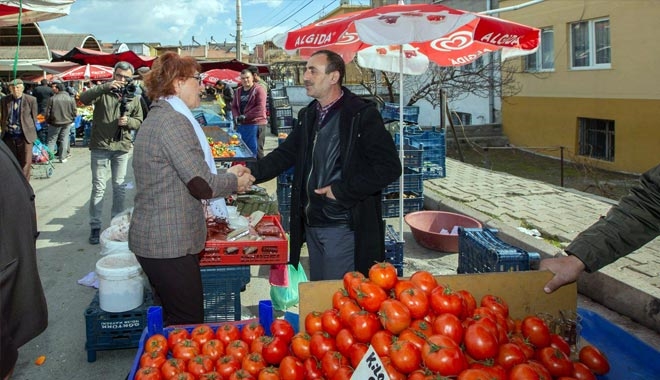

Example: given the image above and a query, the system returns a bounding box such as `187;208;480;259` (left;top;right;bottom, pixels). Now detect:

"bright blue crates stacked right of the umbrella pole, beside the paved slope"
395;127;447;179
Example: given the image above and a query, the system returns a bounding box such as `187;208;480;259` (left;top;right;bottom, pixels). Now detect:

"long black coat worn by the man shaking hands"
248;88;401;275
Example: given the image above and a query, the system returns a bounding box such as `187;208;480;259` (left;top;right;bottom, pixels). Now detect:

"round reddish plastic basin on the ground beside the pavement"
404;211;482;252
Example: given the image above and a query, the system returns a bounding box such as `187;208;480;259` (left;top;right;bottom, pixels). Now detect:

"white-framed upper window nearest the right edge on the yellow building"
570;18;612;69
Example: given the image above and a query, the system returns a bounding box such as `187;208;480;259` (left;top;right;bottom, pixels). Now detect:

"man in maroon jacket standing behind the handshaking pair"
231;69;268;158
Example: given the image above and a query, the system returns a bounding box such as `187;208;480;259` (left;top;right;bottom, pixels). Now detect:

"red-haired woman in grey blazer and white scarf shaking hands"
128;52;254;325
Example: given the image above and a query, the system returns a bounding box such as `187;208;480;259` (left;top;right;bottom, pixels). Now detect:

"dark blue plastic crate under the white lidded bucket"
85;289;154;363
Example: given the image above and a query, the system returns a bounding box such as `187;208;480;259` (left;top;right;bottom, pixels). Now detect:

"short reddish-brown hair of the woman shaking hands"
144;52;201;100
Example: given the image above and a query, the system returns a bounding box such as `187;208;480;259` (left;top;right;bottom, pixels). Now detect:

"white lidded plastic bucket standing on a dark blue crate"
96;253;144;313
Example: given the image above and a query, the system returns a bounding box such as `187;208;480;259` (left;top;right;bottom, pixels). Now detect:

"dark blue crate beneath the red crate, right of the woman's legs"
200;265;250;323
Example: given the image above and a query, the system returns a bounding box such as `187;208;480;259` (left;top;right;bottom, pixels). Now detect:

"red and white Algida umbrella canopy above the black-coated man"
284;4;539;69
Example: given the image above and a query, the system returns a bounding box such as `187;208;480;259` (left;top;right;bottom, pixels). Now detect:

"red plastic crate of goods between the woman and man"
199;215;289;266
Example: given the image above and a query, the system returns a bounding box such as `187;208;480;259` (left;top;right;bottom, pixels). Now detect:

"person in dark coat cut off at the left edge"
0;140;48;379
